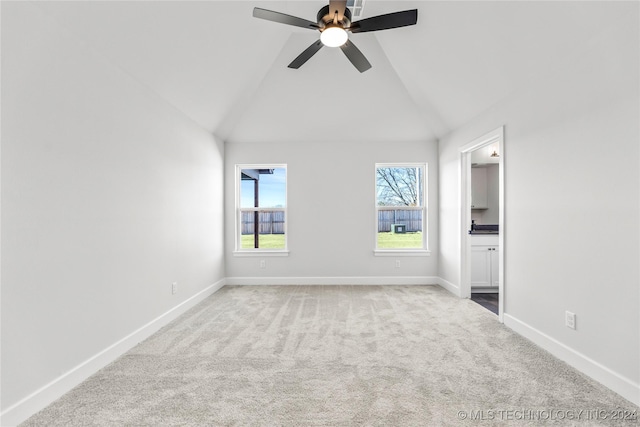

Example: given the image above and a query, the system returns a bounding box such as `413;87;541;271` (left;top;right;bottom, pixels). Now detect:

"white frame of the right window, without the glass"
373;162;431;256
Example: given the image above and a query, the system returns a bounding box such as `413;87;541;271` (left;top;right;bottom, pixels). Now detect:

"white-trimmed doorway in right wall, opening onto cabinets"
460;126;506;322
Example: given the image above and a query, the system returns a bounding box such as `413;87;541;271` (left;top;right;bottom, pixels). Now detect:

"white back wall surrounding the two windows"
225;141;438;283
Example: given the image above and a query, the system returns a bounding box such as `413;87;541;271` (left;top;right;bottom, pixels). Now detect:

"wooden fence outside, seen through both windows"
242;209;422;234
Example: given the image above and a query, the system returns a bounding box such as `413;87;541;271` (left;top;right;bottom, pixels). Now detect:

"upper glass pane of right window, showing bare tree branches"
376;167;422;206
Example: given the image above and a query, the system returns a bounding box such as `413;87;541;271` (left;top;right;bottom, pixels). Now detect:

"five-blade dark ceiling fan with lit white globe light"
253;0;418;73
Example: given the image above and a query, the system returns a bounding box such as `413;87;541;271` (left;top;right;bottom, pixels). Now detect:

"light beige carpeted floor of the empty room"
23;286;638;426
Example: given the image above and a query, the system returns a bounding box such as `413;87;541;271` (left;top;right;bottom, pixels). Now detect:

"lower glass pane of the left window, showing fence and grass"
240;210;285;249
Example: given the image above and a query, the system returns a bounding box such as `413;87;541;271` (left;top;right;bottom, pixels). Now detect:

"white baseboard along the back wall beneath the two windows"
226;276;438;285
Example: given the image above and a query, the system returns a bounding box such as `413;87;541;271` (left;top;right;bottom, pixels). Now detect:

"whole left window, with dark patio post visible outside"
236;165;287;255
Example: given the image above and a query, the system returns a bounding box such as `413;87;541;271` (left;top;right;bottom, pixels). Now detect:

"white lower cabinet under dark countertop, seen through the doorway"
471;235;500;290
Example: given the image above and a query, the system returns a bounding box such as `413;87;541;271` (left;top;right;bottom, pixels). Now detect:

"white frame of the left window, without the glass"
233;163;289;256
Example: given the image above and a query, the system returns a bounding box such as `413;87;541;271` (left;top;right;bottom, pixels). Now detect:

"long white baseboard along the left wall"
0;279;226;427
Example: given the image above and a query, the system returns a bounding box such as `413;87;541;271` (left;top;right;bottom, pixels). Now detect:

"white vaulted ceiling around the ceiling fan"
36;0;621;142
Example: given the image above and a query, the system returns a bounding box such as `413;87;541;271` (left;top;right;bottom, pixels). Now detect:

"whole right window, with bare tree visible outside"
376;163;427;255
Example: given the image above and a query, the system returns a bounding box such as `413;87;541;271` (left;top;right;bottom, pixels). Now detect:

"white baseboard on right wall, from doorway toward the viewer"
503;313;640;406
